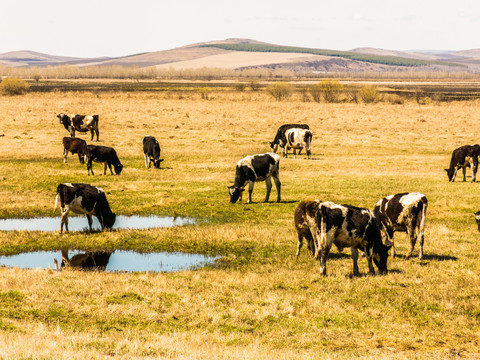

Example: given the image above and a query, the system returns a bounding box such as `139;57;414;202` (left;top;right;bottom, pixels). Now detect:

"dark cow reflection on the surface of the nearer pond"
53;249;112;271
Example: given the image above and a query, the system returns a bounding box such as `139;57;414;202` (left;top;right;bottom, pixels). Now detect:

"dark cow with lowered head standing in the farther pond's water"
54;183;116;232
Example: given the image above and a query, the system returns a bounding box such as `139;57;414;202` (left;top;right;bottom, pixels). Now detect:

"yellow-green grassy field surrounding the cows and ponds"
0;91;480;359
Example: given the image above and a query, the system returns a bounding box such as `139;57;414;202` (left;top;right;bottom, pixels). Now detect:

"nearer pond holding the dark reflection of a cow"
0;250;217;272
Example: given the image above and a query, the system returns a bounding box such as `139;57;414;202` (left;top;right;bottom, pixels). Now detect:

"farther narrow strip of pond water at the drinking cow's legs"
0;215;195;231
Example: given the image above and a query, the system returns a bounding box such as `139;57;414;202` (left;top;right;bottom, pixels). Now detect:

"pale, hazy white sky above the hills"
0;0;480;57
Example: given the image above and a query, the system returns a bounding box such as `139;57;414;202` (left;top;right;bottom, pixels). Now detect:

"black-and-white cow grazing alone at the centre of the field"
228;153;281;204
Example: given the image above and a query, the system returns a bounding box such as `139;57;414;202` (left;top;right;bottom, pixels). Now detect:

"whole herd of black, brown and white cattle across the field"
55;114;480;275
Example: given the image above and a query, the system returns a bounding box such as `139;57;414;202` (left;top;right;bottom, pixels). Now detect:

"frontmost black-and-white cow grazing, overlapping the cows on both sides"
301;201;390;276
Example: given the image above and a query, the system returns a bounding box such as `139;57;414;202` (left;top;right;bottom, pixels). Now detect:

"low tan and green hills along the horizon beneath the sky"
0;39;480;73
